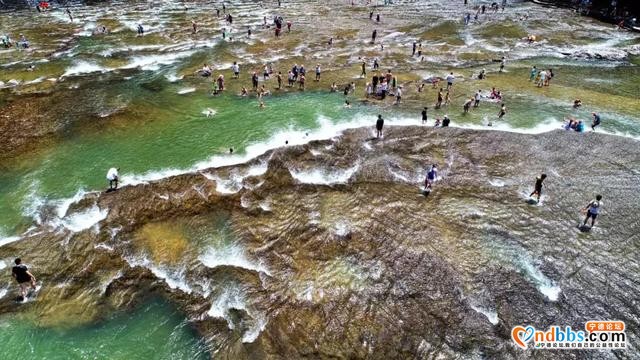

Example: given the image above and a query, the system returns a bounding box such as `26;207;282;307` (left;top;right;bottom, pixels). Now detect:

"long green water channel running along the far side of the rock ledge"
0;70;640;234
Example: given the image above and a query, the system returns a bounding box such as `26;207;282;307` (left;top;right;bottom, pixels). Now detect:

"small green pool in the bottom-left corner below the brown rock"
0;301;208;359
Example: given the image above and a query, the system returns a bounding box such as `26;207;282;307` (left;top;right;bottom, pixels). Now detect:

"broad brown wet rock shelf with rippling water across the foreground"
0;127;640;359
